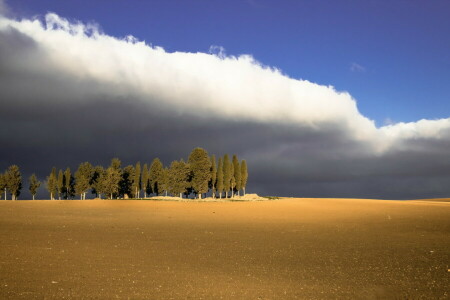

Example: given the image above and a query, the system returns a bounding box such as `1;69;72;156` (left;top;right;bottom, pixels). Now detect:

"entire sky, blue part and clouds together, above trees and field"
0;0;450;199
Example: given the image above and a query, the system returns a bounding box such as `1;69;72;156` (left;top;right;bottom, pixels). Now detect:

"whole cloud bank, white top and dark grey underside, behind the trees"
0;14;450;198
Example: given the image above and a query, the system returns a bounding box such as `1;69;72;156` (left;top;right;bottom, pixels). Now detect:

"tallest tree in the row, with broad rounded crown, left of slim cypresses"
188;148;211;199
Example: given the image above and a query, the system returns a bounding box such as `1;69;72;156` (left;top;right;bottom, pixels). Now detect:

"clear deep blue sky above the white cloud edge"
7;0;450;125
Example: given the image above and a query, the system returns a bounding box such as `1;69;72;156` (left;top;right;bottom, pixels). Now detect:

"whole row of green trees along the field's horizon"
0;148;248;200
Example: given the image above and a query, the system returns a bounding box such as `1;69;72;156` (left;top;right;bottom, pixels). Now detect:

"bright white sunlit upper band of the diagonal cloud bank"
0;12;450;153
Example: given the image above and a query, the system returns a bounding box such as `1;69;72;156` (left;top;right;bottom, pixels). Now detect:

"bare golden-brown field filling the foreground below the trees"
0;199;450;299
